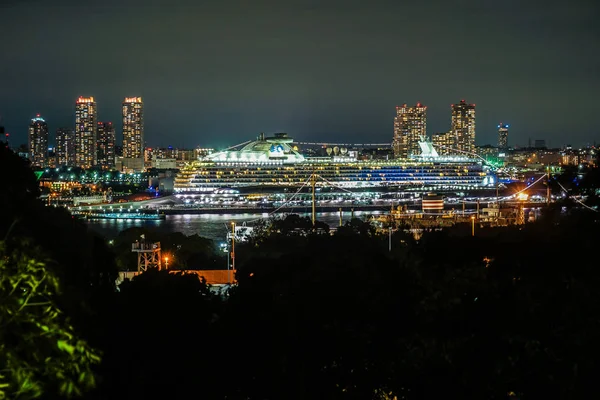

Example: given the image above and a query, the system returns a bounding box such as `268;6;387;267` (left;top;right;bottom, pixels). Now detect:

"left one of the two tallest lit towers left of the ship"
75;97;98;168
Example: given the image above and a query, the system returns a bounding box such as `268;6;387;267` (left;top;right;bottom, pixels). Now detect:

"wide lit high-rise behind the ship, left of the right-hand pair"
392;103;427;158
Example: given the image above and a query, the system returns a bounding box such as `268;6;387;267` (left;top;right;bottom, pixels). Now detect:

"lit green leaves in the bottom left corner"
0;242;100;399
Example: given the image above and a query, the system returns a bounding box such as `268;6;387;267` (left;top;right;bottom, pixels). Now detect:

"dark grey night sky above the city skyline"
0;0;600;147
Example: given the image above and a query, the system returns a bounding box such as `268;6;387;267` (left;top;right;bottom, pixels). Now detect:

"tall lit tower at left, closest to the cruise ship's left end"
123;97;144;159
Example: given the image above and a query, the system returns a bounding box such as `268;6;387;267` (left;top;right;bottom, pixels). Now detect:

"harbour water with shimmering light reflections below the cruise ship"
87;211;381;240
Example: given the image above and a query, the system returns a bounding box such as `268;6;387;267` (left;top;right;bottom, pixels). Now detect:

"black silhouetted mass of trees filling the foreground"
0;140;600;400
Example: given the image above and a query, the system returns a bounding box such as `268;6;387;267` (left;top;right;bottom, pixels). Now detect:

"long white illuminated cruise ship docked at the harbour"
175;133;495;193
